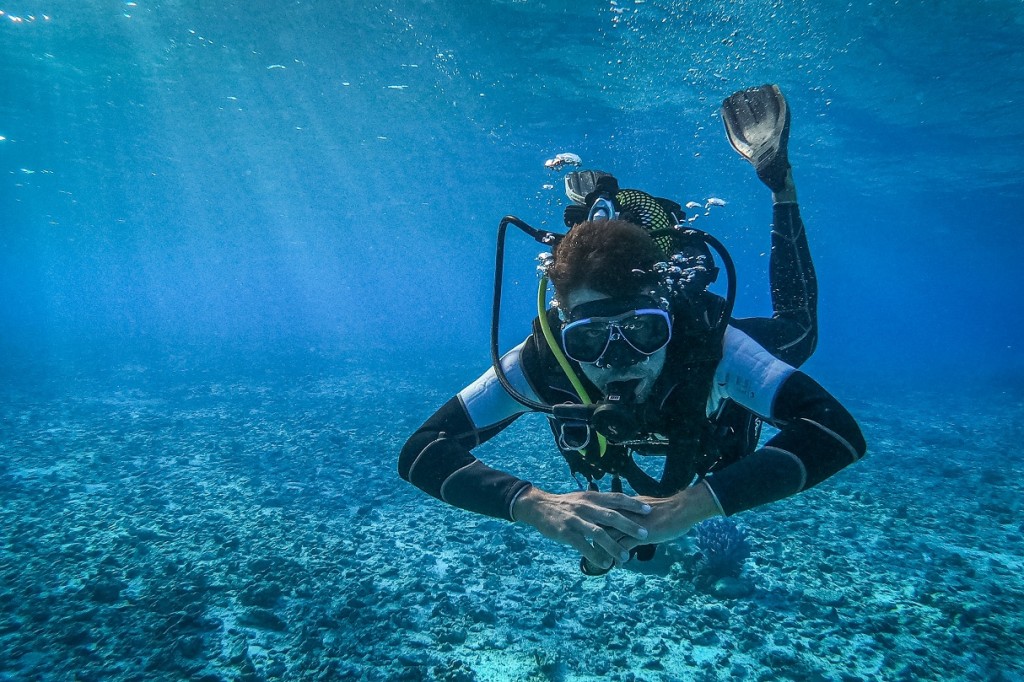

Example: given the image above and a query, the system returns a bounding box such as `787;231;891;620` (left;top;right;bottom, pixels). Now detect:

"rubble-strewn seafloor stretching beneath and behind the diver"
0;356;1024;682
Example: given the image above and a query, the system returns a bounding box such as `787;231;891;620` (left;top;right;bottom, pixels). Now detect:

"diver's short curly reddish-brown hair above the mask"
548;220;662;301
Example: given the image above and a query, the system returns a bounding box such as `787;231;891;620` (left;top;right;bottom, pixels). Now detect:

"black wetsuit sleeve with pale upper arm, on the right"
706;328;866;516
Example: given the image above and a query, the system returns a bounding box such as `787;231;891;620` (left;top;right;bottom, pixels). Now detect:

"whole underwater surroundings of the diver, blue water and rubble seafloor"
0;0;1024;682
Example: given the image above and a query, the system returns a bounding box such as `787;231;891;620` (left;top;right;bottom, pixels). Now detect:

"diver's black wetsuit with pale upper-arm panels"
398;203;865;520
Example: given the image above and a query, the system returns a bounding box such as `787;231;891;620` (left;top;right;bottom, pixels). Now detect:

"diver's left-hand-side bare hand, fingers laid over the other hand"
512;487;651;568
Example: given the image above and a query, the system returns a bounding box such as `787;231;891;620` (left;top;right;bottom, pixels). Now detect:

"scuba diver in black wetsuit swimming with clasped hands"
398;85;866;576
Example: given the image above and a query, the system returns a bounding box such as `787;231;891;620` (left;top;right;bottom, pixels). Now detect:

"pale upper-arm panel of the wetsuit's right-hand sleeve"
708;327;796;418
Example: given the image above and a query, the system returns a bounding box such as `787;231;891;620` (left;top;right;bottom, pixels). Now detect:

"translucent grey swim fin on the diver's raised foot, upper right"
722;84;790;193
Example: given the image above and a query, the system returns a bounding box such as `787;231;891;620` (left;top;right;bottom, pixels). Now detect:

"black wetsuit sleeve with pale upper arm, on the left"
398;344;537;521
